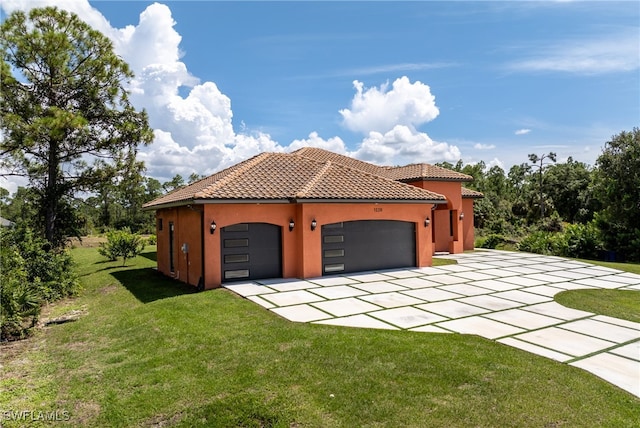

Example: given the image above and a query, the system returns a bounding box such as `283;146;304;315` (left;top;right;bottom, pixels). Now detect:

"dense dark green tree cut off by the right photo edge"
595;128;640;260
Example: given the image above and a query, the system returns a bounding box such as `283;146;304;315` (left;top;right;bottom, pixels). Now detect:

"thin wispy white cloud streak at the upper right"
508;28;640;75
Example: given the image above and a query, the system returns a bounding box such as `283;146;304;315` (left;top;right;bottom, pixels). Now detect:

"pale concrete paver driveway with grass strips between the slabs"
225;250;640;397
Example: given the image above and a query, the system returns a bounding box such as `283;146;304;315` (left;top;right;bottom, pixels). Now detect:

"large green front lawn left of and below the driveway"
0;248;640;427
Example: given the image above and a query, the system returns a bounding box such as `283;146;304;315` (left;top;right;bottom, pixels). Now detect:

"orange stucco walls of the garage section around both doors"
156;203;433;288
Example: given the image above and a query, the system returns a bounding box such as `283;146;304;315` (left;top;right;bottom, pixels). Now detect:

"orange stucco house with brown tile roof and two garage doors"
143;148;482;289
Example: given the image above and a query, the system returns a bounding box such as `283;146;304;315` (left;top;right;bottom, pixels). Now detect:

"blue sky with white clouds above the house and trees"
2;0;640;189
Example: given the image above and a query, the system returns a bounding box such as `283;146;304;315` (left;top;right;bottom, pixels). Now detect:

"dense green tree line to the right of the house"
439;127;640;261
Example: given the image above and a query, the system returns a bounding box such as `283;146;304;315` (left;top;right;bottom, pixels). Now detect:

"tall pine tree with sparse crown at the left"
0;7;153;247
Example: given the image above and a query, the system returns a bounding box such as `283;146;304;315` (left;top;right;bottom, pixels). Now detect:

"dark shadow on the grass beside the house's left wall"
111;268;196;303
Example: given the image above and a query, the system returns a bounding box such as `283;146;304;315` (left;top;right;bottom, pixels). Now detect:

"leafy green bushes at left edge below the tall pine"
0;223;79;340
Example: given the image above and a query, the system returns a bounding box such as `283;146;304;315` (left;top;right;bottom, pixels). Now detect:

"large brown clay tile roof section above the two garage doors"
143;153;446;209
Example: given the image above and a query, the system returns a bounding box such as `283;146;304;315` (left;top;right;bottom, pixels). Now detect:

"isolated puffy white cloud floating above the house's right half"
340;76;440;134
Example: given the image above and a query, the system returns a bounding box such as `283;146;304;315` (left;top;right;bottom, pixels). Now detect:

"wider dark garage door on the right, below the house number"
322;220;416;275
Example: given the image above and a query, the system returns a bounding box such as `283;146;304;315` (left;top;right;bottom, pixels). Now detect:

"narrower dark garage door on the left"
220;223;282;282
